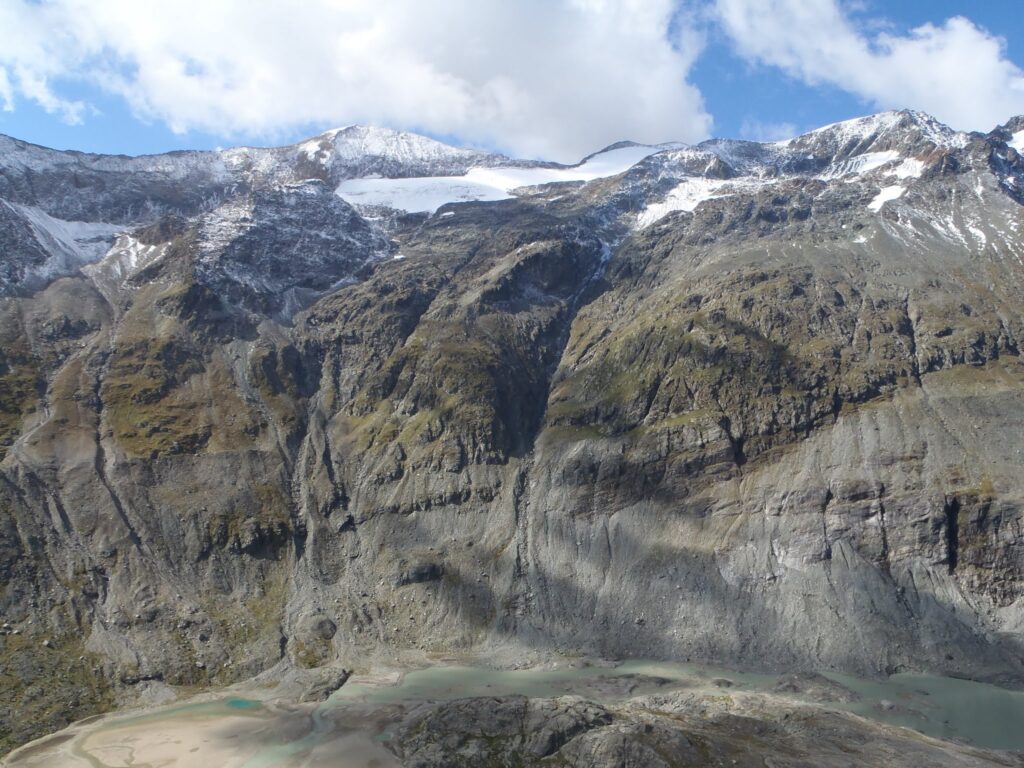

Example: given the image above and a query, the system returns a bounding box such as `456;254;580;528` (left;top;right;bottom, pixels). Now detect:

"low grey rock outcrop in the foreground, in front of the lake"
390;693;1022;768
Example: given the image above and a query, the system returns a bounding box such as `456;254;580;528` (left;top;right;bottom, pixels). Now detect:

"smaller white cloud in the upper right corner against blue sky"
715;0;1024;130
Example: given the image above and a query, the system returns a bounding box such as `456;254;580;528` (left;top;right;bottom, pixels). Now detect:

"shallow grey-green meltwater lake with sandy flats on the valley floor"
11;659;1024;768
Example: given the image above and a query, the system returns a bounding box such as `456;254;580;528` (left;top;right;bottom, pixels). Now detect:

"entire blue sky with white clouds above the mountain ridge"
0;0;1024;160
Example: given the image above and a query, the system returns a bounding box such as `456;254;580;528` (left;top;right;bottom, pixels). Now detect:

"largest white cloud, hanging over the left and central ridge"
0;0;711;160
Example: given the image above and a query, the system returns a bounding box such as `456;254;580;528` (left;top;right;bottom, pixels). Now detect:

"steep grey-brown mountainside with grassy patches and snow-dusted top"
0;113;1024;745
